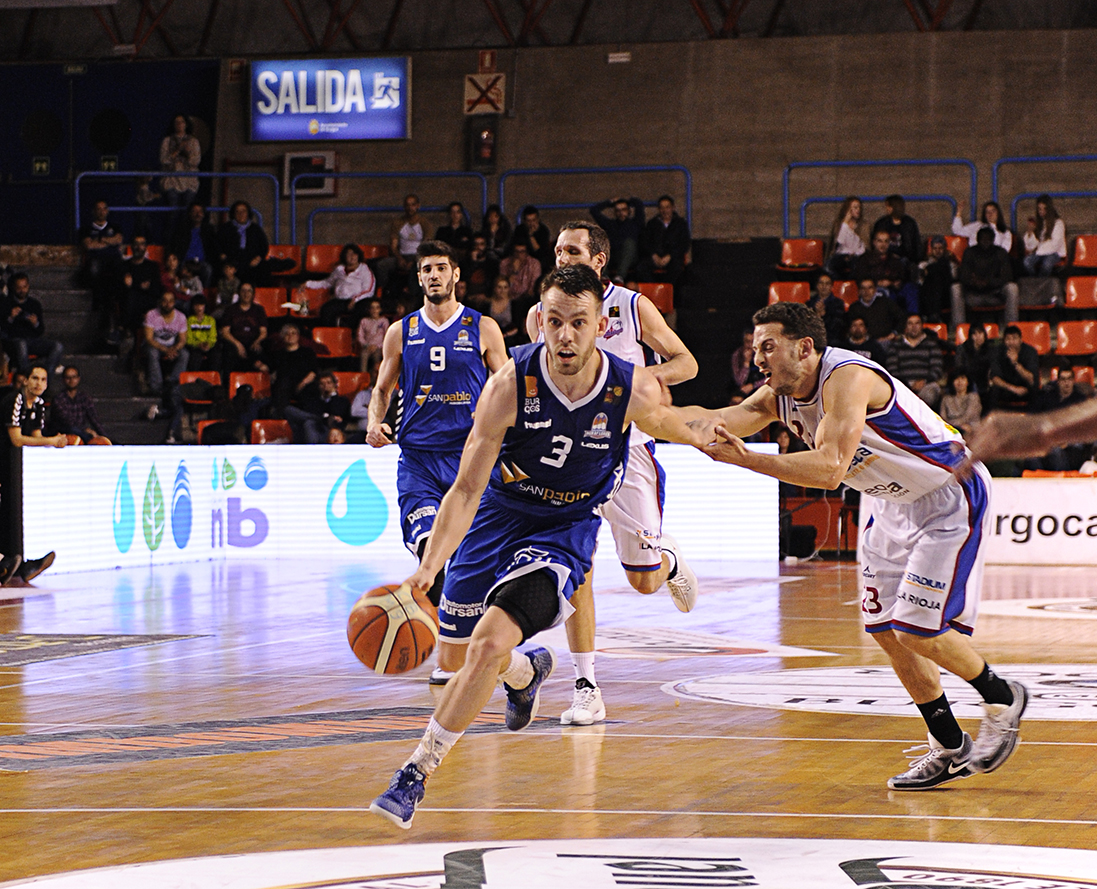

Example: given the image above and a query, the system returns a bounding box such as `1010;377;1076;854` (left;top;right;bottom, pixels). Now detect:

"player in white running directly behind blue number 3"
525;221;697;725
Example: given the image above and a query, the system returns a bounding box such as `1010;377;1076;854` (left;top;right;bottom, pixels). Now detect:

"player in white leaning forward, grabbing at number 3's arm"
682;303;1028;790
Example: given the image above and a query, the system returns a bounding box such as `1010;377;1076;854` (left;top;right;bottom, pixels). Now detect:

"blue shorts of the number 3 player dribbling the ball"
438;494;601;643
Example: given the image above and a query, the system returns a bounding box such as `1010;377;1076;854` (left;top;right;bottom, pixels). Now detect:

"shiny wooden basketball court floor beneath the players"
0;553;1097;880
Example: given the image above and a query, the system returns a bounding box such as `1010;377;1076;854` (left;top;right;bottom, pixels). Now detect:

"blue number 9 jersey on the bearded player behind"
396;306;487;451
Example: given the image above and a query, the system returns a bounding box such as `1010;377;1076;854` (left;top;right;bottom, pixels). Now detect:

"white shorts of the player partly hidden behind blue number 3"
598;443;665;571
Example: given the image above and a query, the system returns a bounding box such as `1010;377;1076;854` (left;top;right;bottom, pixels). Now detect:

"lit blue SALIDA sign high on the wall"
250;56;411;142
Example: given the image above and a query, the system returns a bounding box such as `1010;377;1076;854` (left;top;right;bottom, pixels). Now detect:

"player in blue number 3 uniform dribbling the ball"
370;266;703;828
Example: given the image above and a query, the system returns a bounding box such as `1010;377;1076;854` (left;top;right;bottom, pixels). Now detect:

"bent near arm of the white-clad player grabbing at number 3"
704;364;891;491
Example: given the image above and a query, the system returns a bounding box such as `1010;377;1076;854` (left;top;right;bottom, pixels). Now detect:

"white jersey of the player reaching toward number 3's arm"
777;348;964;503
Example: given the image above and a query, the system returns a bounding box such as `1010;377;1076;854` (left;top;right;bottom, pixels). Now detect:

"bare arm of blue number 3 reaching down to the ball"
408;361;518;590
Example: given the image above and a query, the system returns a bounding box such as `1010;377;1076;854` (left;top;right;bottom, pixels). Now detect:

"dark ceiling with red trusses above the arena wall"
0;0;1097;61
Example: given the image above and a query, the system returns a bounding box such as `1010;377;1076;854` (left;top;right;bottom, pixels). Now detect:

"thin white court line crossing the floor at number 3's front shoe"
0;806;1097;828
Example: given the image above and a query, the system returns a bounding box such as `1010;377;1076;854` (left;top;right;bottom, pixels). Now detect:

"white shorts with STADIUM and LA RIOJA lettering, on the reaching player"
857;463;991;637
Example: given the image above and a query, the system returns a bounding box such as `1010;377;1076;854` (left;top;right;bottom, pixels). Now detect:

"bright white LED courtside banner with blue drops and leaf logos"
23;445;778;581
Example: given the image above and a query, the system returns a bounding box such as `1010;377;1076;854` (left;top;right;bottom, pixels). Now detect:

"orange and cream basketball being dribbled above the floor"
347;584;438;673
